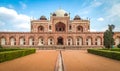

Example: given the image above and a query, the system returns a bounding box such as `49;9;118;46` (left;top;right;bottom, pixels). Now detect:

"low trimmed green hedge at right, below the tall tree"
87;49;120;60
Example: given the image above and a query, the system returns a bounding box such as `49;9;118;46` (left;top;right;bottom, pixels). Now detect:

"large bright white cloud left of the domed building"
0;7;30;31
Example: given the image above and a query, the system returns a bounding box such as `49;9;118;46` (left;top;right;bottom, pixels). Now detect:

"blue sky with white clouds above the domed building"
0;0;120;32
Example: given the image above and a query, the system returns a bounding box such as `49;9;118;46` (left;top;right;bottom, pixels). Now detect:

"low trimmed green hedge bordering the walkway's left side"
0;49;36;63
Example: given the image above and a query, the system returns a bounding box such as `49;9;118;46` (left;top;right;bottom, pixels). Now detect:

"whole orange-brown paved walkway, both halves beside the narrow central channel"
0;50;120;71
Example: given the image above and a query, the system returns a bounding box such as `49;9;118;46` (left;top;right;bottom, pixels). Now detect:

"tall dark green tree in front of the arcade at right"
103;24;115;49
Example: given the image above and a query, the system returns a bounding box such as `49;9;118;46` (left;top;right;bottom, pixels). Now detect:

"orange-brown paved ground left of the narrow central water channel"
0;50;59;71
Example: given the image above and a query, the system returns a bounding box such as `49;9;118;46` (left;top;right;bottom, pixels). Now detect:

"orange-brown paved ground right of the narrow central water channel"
62;50;120;71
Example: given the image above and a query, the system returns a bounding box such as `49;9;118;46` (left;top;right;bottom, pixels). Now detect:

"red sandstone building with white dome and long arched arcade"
0;9;120;47
